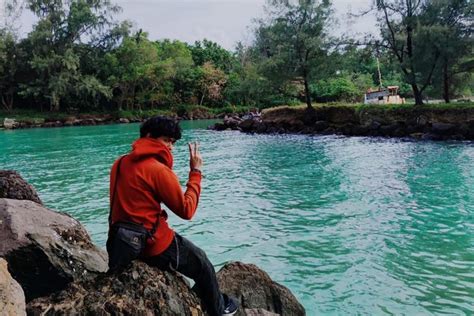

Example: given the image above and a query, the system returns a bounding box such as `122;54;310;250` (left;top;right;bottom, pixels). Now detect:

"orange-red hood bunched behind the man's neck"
129;137;173;169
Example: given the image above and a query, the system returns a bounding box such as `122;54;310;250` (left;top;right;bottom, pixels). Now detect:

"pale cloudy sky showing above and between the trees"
0;0;377;50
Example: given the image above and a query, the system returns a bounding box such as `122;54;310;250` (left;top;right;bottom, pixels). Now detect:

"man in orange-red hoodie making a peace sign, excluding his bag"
110;116;237;315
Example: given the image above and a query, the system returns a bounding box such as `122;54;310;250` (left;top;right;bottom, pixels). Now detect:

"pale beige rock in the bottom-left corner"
0;258;26;315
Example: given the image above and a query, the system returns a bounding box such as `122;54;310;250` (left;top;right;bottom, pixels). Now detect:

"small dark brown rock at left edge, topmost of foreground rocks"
0;170;43;204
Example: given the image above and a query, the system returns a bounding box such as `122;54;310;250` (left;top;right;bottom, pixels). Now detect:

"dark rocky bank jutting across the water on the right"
210;106;474;140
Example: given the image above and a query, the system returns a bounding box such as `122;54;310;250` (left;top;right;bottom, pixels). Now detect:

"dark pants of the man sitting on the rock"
143;234;224;316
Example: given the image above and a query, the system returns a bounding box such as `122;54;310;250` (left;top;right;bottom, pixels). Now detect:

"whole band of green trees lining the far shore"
0;0;474;118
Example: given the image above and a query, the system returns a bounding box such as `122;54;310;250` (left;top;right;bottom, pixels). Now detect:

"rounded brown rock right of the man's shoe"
217;262;306;316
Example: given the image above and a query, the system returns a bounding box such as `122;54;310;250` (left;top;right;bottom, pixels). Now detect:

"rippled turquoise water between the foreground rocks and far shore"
0;121;474;315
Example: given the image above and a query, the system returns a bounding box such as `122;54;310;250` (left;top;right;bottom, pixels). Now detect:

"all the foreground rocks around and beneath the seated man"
0;170;305;316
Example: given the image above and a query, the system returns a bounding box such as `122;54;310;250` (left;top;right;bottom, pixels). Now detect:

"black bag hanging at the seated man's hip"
107;222;151;271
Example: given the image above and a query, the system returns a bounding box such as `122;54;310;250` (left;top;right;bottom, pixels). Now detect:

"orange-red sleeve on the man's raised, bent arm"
155;168;201;220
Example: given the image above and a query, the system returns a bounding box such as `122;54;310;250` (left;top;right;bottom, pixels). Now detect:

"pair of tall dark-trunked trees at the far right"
376;0;474;105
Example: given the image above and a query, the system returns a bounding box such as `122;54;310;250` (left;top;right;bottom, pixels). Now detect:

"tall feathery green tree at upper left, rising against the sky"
21;0;118;111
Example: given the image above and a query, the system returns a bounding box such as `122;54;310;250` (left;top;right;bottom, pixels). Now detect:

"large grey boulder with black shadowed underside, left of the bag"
0;198;107;302
